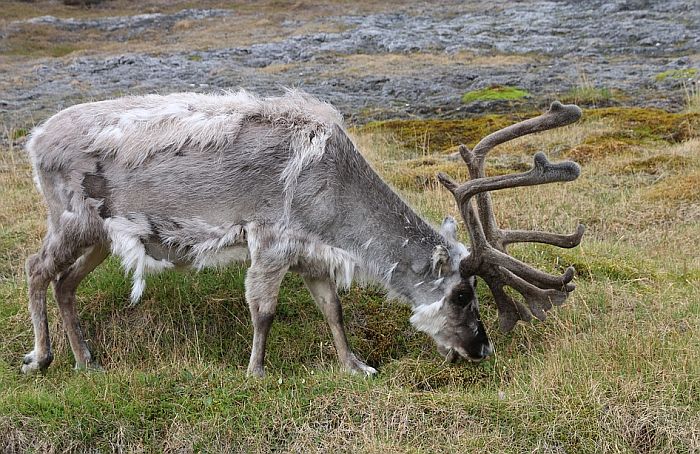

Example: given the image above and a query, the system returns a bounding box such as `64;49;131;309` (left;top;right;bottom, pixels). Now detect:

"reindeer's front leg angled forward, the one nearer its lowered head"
302;275;377;376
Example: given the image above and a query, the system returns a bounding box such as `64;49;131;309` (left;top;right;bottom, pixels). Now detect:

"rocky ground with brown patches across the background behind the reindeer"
0;0;700;126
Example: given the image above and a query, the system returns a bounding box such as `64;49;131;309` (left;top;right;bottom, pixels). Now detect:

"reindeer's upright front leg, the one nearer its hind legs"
245;262;287;377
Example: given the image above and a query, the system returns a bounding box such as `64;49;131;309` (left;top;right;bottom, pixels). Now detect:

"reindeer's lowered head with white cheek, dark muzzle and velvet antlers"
411;102;584;361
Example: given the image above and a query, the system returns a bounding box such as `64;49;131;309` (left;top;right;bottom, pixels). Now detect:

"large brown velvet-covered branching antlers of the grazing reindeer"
438;101;585;331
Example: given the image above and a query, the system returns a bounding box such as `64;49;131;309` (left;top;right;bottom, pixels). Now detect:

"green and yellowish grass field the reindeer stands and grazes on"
0;108;700;452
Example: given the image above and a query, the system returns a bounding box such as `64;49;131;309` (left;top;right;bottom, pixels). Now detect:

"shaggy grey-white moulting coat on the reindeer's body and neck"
27;91;482;376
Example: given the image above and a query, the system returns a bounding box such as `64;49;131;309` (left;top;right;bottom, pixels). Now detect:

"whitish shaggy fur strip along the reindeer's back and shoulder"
27;90;342;168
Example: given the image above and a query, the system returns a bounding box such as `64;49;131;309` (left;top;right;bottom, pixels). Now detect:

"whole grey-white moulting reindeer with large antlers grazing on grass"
22;91;583;376
